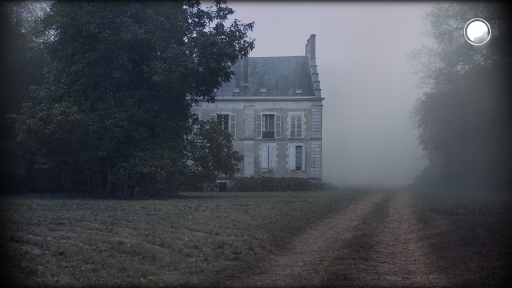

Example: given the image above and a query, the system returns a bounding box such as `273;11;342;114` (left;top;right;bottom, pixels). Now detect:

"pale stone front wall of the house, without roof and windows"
193;97;323;178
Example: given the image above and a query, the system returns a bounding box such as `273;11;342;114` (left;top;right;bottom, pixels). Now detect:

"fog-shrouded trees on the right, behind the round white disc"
409;2;512;188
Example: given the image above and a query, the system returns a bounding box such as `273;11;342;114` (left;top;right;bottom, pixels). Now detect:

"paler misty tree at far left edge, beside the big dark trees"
0;2;47;192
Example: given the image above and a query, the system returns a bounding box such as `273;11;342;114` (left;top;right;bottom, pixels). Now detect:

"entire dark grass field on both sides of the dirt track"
0;188;512;287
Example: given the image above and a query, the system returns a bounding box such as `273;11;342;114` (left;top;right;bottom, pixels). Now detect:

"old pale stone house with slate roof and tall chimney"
192;34;324;190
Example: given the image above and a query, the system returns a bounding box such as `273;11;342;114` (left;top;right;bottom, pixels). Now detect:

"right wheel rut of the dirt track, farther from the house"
323;190;446;287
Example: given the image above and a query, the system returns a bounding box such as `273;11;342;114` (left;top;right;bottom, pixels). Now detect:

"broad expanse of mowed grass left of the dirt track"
1;188;369;287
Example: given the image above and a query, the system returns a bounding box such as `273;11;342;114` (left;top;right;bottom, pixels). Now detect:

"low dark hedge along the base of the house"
231;176;326;192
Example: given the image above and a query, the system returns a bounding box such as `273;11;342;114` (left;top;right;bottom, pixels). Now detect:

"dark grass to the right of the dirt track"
414;189;512;287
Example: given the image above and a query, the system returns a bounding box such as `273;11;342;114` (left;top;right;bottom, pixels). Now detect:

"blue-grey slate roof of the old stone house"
217;56;315;97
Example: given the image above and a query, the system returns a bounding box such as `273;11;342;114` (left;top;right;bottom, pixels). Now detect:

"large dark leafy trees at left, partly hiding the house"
2;1;254;195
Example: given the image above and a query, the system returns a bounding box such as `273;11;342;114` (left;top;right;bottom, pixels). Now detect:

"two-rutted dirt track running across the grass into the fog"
229;190;446;287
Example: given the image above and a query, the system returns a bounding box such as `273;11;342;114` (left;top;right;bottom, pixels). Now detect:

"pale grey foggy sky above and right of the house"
228;2;431;185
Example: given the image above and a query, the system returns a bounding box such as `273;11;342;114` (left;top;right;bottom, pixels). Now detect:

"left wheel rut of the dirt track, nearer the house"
228;192;382;287
